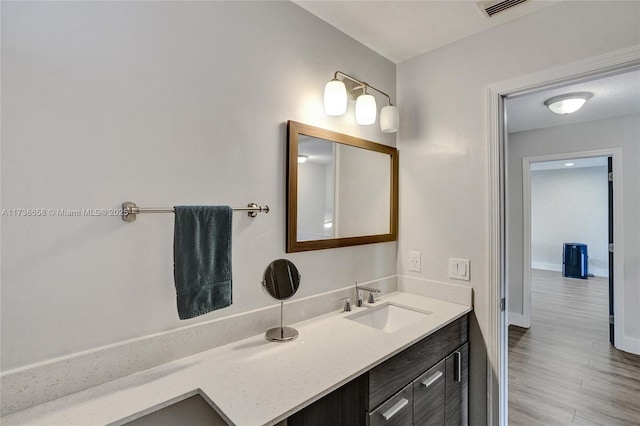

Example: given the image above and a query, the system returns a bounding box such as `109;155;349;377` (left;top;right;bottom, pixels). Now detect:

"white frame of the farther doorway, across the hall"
517;148;624;334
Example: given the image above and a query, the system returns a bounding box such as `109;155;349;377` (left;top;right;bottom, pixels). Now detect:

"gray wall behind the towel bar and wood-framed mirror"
1;1;396;371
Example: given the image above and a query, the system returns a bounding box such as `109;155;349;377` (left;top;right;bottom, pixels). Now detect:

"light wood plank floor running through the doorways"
509;270;640;426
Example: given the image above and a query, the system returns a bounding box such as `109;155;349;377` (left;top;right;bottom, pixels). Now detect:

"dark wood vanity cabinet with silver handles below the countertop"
287;315;469;426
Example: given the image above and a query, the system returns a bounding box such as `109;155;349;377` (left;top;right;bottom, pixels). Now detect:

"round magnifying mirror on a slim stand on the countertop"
262;259;300;342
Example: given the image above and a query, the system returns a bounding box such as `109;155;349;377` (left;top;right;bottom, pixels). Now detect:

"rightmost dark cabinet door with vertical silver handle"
445;343;469;426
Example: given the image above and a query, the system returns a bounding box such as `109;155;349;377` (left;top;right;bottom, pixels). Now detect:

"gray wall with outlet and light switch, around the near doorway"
397;1;640;425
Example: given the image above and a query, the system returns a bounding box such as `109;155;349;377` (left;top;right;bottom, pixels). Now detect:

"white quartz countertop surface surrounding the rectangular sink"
2;292;471;426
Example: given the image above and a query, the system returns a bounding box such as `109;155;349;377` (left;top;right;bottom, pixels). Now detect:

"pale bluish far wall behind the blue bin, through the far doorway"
531;166;609;277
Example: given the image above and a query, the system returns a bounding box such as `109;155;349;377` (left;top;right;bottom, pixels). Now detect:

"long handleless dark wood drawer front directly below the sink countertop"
368;315;467;410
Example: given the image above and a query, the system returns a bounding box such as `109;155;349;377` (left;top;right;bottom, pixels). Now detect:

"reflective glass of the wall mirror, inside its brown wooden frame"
297;135;391;241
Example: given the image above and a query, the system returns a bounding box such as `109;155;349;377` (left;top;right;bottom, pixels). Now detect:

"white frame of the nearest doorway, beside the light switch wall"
485;45;640;425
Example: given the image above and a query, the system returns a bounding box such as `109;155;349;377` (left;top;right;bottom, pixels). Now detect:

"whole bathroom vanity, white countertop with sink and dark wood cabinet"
2;289;471;426
